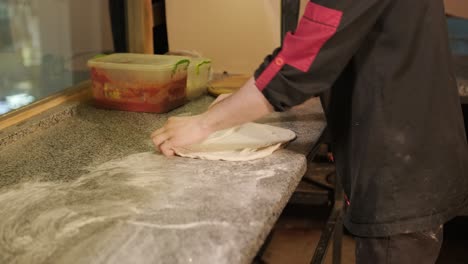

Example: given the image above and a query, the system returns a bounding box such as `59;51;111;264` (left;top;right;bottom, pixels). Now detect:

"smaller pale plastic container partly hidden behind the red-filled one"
187;58;211;100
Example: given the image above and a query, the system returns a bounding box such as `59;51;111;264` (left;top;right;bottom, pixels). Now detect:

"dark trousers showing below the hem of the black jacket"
356;226;443;264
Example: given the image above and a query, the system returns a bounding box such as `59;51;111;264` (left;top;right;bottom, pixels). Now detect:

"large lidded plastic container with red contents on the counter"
88;53;190;113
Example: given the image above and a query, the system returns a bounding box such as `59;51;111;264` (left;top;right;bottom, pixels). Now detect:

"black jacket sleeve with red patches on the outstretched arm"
254;0;389;111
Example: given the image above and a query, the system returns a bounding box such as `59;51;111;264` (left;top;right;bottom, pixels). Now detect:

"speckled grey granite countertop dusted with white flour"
0;96;326;264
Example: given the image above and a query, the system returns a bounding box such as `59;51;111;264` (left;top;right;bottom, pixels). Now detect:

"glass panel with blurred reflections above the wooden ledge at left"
0;0;113;114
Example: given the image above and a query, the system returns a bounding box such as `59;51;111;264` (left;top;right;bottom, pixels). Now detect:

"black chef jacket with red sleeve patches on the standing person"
255;0;468;237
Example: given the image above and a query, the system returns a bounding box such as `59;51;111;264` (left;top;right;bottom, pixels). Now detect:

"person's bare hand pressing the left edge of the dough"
151;115;211;156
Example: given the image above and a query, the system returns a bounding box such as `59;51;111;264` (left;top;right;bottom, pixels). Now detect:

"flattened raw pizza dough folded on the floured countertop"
174;123;296;161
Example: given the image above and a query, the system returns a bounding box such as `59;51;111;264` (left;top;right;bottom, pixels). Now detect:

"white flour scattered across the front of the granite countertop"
0;152;286;263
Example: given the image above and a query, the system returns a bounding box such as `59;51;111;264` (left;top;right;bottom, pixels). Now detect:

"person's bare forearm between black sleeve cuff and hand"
202;78;273;131
